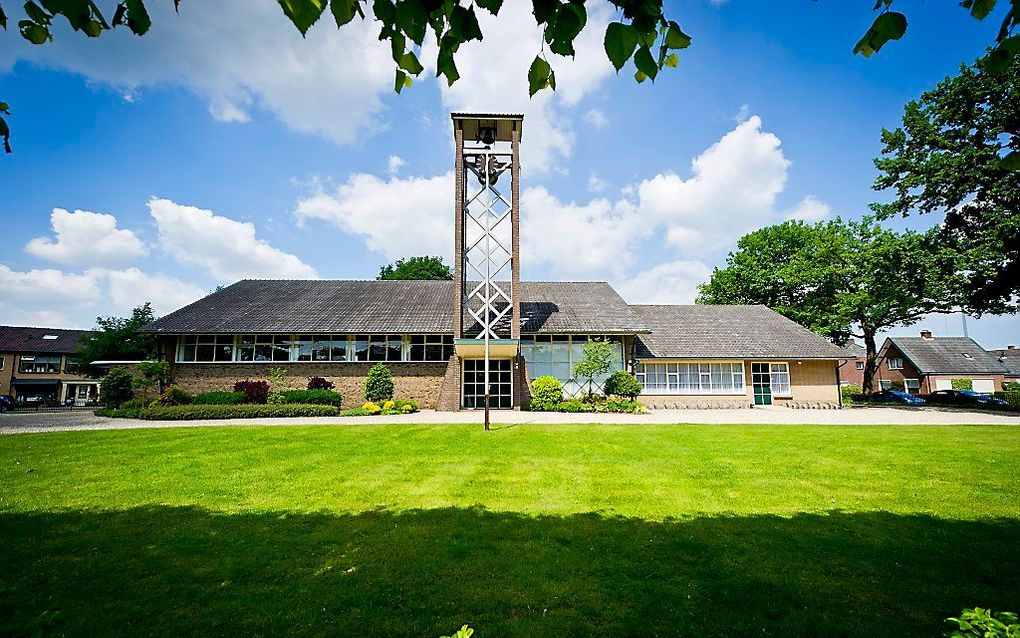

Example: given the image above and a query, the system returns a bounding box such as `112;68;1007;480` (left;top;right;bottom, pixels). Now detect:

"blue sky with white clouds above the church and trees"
0;0;1020;347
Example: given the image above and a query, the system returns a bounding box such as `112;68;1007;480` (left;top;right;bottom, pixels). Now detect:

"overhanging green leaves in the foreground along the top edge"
0;0;1020;152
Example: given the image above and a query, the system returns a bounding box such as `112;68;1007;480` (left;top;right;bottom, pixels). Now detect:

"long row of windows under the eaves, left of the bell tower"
176;335;453;363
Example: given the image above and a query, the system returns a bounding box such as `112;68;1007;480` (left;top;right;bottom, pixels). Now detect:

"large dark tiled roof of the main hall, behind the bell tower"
147;280;643;334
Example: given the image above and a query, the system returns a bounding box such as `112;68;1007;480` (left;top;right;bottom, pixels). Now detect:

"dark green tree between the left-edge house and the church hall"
73;301;158;378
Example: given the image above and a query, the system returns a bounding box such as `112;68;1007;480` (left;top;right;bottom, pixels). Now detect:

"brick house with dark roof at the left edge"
0;326;99;405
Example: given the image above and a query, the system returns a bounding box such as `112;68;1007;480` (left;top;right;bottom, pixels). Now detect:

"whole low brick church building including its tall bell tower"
146;113;849;410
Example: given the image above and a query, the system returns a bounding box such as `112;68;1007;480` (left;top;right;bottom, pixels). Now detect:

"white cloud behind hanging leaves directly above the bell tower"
423;1;613;173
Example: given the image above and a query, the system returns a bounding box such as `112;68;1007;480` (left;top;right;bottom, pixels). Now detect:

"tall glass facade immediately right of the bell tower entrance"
520;335;623;396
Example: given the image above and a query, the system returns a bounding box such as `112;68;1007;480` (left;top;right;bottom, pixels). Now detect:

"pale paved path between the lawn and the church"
0;407;1020;434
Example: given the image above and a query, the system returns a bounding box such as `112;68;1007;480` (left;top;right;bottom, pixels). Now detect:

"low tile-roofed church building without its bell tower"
139;280;847;409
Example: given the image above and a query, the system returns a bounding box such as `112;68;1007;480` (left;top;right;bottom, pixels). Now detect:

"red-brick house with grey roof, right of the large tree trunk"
877;330;1006;394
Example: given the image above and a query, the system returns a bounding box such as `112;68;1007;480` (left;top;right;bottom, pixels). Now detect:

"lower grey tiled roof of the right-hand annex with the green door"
630;305;854;359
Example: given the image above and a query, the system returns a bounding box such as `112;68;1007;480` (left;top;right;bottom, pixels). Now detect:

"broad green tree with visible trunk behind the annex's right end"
698;217;960;392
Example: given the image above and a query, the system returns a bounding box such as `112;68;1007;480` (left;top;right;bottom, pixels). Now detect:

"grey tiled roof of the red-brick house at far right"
882;337;1006;375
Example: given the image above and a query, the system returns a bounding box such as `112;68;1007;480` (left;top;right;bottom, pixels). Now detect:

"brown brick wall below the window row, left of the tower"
172;361;448;409
